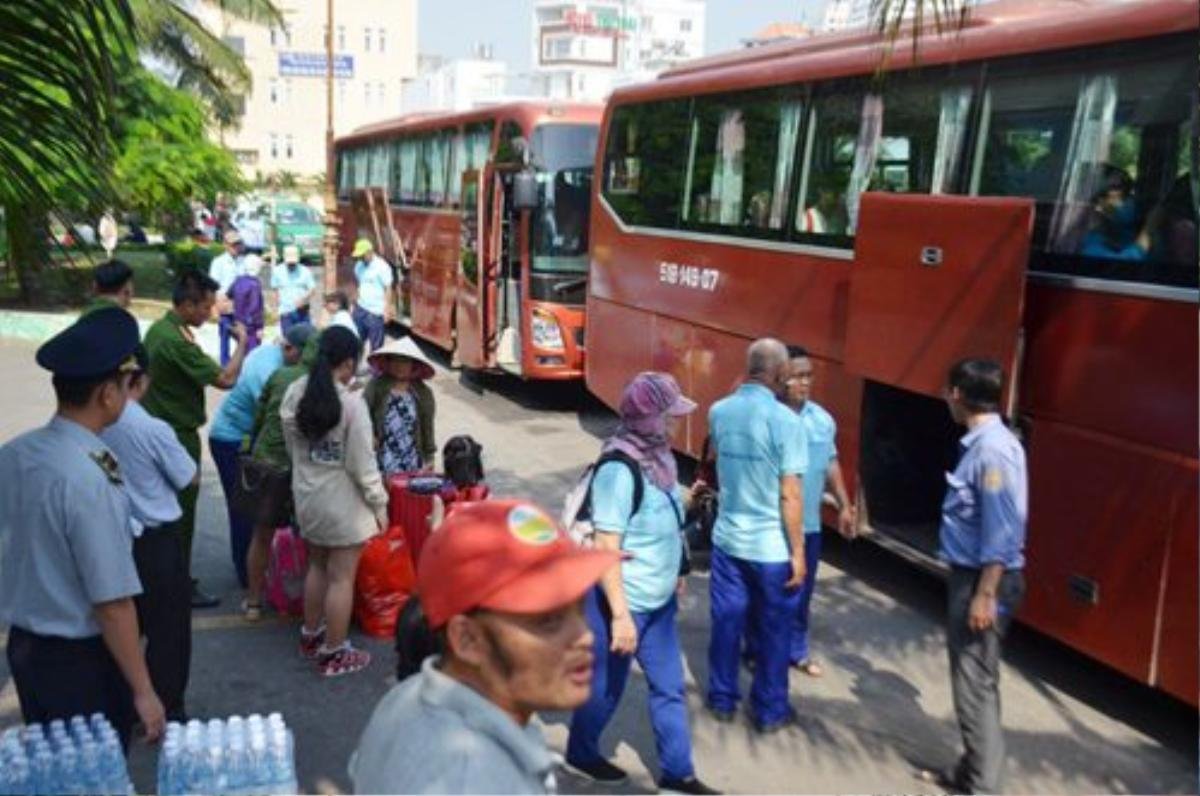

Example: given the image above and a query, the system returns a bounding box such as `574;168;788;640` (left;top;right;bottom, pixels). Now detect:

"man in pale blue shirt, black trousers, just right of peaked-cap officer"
100;347;198;722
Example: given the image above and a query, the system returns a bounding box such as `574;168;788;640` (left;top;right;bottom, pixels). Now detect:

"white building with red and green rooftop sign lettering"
533;0;707;101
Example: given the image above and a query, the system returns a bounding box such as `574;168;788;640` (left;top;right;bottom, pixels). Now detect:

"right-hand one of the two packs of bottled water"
158;713;298;796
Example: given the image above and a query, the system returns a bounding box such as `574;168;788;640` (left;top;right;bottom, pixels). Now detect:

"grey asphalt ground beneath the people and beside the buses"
0;342;1198;794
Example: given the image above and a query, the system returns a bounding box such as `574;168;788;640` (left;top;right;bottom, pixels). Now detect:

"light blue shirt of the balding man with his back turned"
708;384;809;563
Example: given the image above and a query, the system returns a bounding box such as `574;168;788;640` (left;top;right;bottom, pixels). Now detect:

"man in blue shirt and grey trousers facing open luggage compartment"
941;359;1028;794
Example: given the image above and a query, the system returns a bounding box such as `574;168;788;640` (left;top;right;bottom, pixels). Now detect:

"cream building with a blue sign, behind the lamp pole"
194;0;416;178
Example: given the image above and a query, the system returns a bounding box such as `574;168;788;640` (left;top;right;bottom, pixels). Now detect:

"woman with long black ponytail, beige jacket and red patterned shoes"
280;327;388;677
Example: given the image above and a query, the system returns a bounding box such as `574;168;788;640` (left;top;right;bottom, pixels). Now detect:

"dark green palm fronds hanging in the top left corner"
0;0;133;300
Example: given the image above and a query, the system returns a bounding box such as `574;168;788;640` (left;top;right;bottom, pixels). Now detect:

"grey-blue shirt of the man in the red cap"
350;658;556;794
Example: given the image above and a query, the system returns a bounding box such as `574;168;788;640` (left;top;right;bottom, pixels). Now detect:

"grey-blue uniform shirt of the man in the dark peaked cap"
0;417;142;639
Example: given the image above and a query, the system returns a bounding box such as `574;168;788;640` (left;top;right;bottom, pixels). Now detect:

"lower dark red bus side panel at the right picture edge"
1158;466;1200;705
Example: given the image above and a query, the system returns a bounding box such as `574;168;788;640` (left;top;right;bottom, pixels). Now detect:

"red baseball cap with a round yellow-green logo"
416;501;619;629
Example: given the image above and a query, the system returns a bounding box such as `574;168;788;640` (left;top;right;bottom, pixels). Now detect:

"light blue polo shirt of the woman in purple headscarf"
592;461;683;614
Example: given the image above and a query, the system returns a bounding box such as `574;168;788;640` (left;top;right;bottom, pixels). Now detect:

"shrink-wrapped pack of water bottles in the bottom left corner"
0;713;133;796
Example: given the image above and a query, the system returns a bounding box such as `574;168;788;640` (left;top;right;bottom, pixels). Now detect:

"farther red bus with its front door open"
335;103;601;379
